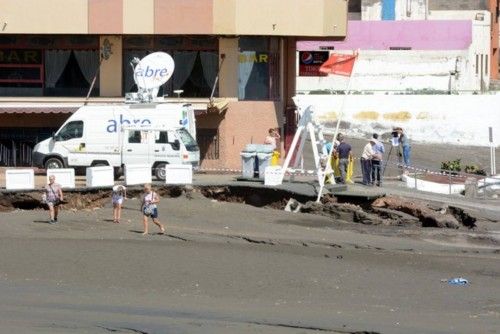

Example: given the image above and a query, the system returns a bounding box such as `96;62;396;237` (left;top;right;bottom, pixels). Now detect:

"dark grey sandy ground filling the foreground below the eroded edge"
0;195;500;334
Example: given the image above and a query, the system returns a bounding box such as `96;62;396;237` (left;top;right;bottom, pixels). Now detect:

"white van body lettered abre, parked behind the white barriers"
33;103;200;180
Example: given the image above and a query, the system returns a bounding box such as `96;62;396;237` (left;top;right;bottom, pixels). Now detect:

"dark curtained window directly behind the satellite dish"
123;36;219;97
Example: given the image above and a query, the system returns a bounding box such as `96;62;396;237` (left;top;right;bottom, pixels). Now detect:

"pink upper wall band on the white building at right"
297;20;472;51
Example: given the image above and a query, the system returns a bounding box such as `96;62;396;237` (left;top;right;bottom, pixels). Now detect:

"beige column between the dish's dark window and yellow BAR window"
219;38;239;98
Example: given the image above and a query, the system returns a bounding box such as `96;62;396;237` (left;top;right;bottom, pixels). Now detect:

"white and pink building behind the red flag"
297;0;499;94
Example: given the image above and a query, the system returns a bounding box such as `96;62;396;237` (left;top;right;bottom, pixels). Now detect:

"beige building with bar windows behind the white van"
0;0;347;168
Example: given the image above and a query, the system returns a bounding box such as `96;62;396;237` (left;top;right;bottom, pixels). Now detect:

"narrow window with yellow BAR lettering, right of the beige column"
238;37;279;100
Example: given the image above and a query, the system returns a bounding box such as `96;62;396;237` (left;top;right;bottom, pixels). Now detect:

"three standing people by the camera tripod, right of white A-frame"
325;127;411;187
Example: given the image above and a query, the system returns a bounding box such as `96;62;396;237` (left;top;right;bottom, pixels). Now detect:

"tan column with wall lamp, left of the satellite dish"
99;36;123;97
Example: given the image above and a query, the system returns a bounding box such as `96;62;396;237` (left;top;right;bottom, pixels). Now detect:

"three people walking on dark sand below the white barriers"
42;175;165;235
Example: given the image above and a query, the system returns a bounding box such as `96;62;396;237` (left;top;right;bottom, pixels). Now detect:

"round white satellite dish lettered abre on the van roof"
134;52;175;90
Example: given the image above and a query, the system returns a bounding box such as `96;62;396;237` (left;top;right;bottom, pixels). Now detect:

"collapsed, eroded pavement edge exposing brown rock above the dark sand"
0;186;486;228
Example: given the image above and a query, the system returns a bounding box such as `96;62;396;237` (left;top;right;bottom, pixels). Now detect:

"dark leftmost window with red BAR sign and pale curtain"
0;35;99;96
